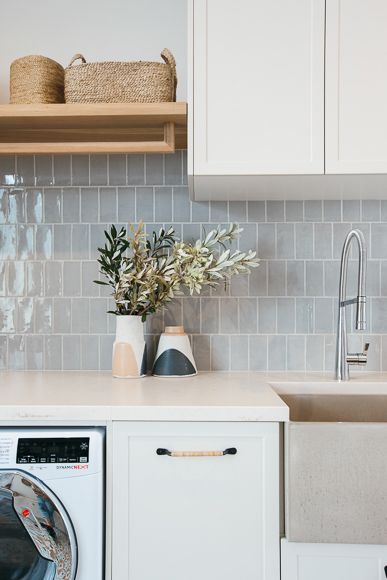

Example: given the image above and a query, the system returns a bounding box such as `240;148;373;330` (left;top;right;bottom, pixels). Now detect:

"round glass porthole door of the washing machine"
0;469;78;580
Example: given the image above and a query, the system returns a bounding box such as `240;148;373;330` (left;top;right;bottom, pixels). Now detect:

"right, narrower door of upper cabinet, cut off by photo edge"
325;0;387;173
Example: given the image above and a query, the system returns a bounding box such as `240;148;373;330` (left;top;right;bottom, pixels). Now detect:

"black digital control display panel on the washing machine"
16;437;90;463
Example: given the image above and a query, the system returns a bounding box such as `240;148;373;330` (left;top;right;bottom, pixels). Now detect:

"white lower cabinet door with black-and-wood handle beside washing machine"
112;422;279;580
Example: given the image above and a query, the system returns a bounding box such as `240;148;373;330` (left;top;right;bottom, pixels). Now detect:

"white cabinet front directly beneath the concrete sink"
281;540;387;580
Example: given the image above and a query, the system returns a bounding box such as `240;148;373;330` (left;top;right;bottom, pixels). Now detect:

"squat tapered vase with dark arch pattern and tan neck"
153;326;198;377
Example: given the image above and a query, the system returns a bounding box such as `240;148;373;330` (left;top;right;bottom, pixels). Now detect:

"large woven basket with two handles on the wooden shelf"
65;48;177;103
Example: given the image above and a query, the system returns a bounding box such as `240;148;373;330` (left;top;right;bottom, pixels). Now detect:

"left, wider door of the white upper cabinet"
189;0;325;175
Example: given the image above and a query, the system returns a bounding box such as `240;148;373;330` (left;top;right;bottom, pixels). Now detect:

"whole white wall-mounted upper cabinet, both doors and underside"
188;0;387;201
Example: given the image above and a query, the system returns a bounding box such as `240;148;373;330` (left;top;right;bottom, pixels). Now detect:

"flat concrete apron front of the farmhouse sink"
285;419;387;544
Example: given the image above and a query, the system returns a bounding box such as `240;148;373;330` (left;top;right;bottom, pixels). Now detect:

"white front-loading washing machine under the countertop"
0;427;104;580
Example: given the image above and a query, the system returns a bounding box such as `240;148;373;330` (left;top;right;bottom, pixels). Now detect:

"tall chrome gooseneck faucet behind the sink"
336;230;369;381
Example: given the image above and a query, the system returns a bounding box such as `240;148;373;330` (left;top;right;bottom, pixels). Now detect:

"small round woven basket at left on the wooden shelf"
10;55;64;105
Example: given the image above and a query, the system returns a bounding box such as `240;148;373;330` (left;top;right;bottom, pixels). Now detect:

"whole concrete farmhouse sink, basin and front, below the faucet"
274;381;387;544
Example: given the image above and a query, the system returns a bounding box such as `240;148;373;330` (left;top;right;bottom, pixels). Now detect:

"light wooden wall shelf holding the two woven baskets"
0;102;187;155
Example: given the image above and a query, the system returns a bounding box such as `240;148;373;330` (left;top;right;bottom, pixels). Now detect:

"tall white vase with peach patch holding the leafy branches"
112;314;147;379
